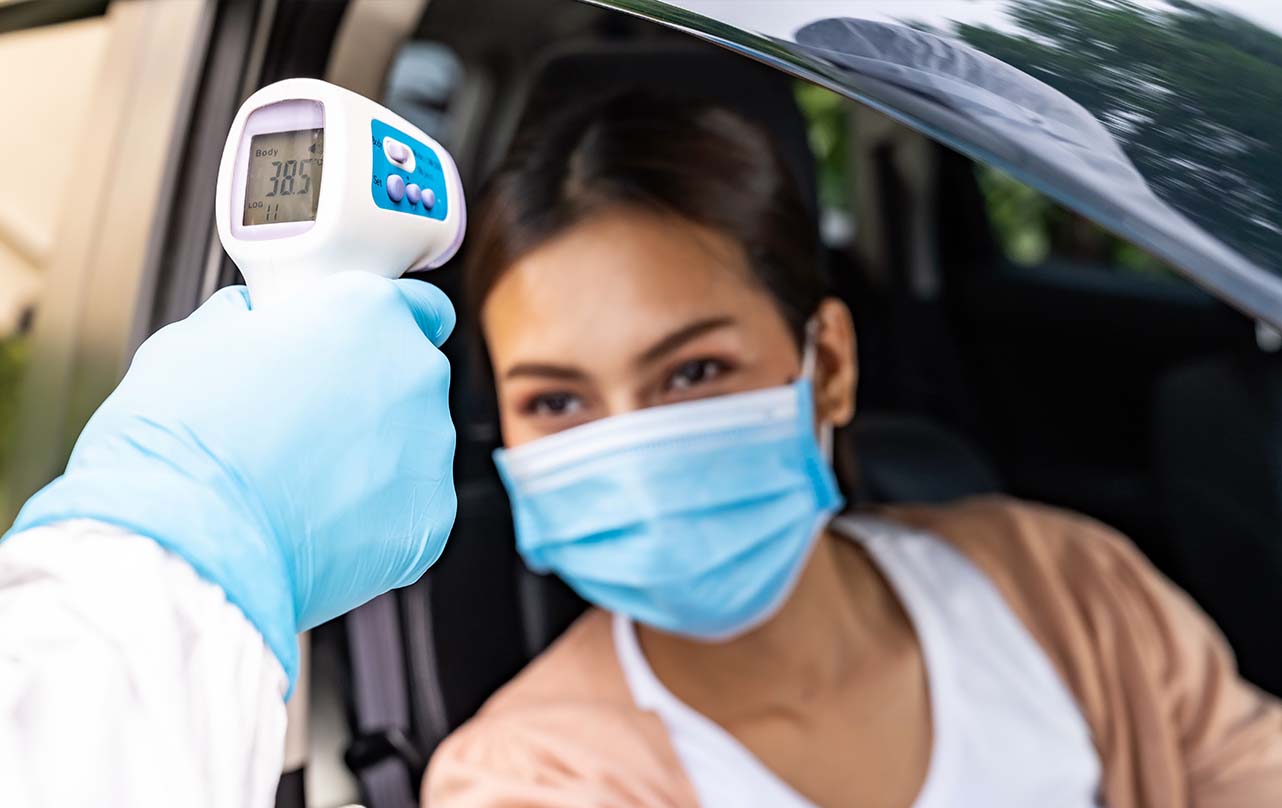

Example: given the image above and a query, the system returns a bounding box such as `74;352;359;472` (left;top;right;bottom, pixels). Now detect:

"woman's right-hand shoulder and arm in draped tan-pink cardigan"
888;498;1282;805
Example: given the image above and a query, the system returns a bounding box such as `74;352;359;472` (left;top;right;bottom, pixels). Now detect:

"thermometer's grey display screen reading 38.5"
241;128;324;227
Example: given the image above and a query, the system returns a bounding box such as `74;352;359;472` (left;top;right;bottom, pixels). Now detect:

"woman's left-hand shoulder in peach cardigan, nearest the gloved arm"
424;609;690;807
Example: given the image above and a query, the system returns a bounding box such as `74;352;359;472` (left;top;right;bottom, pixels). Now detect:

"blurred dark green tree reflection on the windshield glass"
954;0;1282;271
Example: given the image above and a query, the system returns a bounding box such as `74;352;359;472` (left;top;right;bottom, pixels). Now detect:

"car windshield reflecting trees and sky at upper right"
599;0;1282;326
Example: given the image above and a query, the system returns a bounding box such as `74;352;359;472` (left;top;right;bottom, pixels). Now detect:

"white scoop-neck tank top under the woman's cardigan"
614;516;1103;808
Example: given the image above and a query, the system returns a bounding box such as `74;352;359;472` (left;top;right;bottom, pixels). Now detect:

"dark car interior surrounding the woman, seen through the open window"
280;3;1282;807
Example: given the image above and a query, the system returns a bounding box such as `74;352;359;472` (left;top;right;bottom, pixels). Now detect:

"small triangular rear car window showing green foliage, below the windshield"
974;164;1187;282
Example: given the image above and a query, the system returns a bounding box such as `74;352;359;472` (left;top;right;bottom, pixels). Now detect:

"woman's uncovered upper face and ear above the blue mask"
482;209;855;446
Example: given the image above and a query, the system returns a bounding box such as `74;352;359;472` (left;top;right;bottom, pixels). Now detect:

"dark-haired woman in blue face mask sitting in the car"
424;95;1282;808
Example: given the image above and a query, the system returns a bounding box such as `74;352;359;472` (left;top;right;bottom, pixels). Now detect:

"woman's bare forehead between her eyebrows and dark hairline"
482;210;782;363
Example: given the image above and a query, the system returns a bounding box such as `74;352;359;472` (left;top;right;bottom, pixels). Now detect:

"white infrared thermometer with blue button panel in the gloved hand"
217;78;467;308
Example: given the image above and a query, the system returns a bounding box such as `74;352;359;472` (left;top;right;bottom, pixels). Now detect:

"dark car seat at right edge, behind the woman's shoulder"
1153;354;1282;695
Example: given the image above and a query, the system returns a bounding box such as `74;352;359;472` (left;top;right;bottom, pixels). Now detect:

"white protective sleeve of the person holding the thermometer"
0;521;286;808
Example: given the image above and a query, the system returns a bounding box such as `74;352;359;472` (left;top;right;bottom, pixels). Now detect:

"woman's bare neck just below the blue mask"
637;531;912;722
